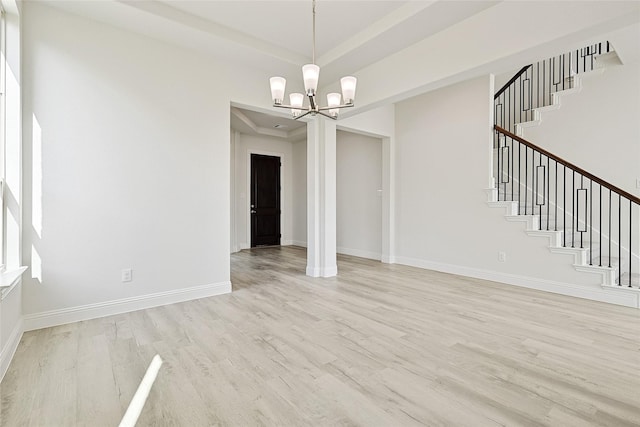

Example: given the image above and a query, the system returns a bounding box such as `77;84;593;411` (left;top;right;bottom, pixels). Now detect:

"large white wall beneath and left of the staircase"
395;77;632;306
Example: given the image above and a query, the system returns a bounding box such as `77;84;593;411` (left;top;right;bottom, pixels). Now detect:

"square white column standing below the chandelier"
307;116;338;277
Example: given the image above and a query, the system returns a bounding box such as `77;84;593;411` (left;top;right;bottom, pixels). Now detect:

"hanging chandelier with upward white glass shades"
269;0;357;120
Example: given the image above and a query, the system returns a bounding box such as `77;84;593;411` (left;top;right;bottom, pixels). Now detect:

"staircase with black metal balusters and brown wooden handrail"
487;42;640;302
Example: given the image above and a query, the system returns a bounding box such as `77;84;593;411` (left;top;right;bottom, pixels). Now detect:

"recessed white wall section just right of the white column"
336;131;382;260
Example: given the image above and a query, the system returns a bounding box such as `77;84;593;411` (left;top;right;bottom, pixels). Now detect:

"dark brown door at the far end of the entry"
251;154;280;248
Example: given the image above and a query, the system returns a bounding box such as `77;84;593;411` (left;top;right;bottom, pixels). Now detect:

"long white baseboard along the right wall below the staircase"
396;257;640;308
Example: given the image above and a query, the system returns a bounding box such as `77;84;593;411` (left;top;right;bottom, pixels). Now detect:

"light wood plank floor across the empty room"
0;247;640;427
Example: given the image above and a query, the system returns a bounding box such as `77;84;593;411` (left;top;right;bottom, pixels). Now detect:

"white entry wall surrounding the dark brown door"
234;133;296;250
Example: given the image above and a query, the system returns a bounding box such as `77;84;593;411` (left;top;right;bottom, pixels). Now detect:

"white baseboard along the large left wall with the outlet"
24;281;231;331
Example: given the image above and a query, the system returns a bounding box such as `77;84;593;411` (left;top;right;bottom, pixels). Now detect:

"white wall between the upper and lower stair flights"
524;62;640;196
